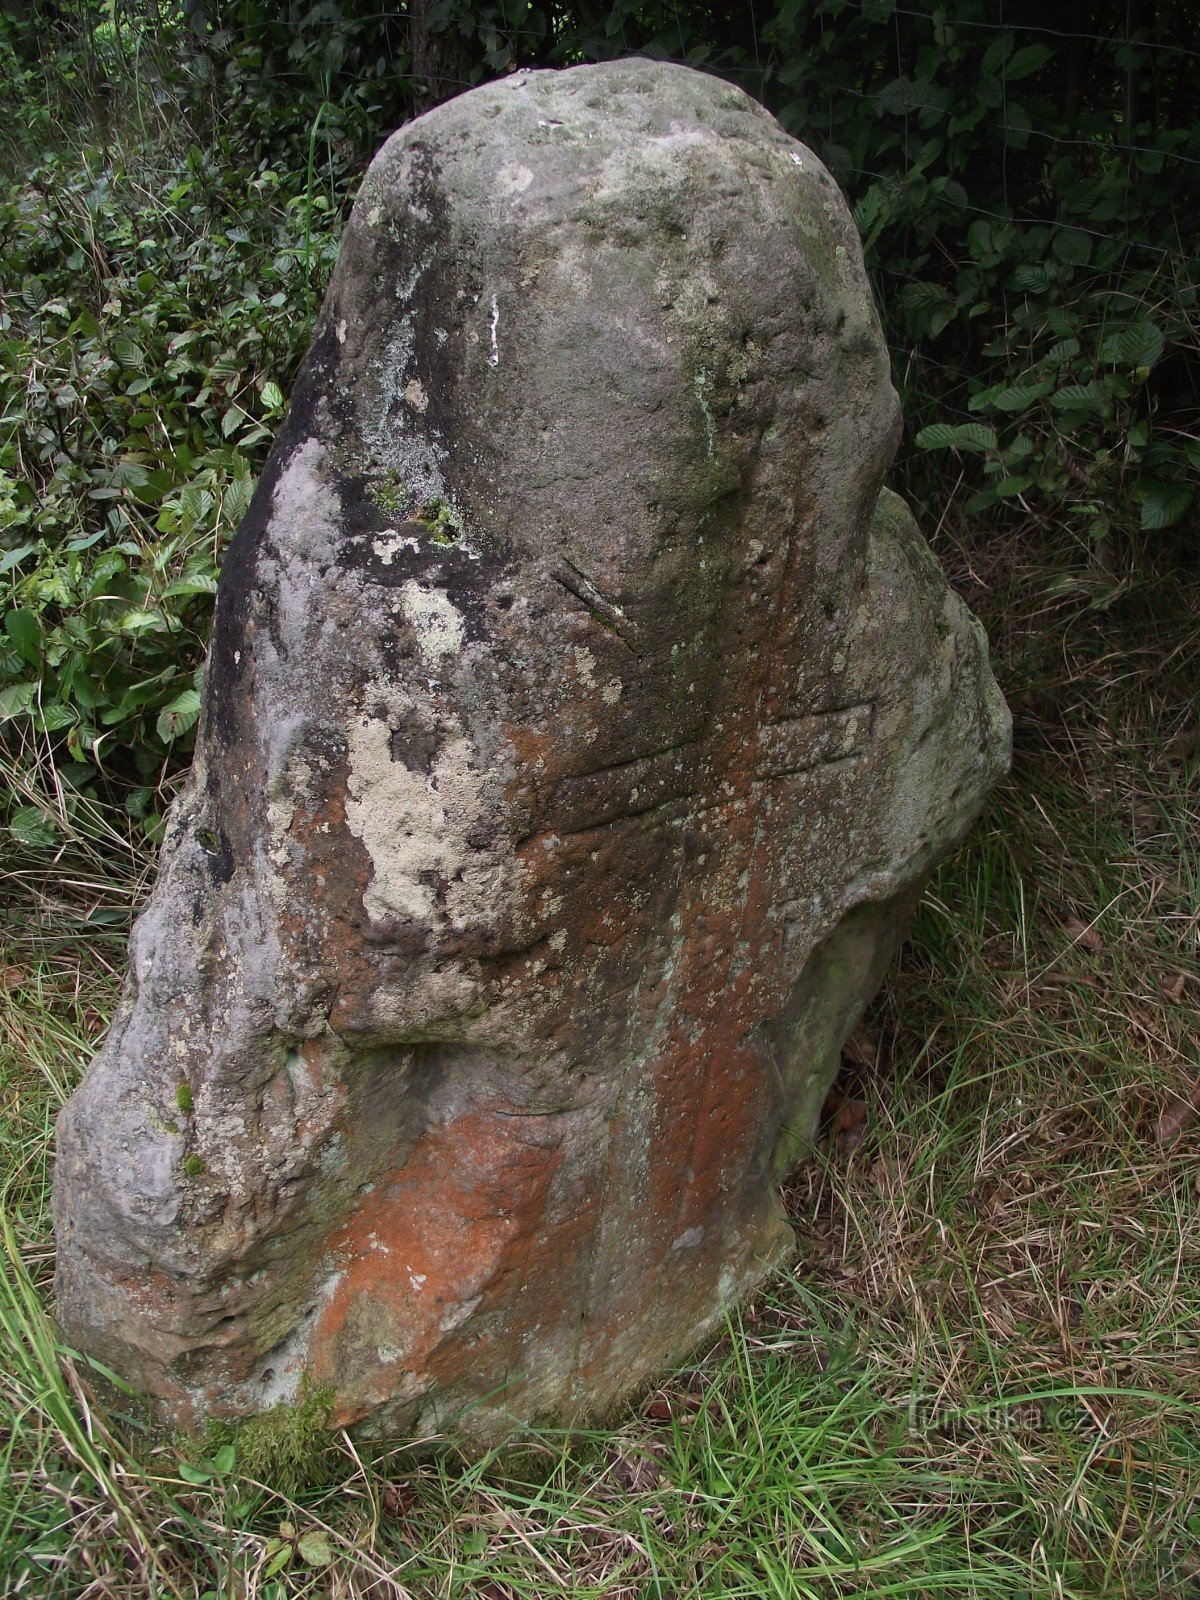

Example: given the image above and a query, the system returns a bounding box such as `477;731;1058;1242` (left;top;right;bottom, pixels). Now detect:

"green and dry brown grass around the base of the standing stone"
0;521;1200;1600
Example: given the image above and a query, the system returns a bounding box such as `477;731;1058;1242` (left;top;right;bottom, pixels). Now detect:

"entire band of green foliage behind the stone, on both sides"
0;0;1200;845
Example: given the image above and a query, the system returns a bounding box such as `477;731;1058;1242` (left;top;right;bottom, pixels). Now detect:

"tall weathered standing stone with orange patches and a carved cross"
56;61;1008;1434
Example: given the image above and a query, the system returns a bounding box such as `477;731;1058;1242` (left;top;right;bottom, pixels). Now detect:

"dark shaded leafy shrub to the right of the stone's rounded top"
742;0;1200;541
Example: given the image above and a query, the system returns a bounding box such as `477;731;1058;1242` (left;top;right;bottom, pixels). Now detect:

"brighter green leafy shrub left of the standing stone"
0;108;345;843
